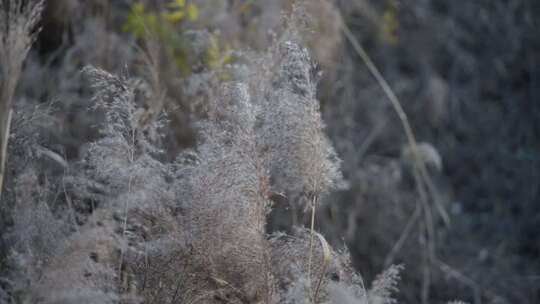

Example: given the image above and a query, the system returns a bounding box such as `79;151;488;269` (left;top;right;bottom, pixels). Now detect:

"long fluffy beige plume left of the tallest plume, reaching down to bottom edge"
181;83;270;302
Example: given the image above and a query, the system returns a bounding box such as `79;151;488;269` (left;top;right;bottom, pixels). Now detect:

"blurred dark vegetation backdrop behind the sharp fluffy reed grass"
0;0;540;303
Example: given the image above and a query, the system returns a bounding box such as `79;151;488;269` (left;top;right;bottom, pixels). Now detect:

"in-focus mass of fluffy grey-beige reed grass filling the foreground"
0;1;410;304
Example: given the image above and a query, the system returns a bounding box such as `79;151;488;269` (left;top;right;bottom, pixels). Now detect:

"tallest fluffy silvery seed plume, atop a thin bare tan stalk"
258;41;342;204
